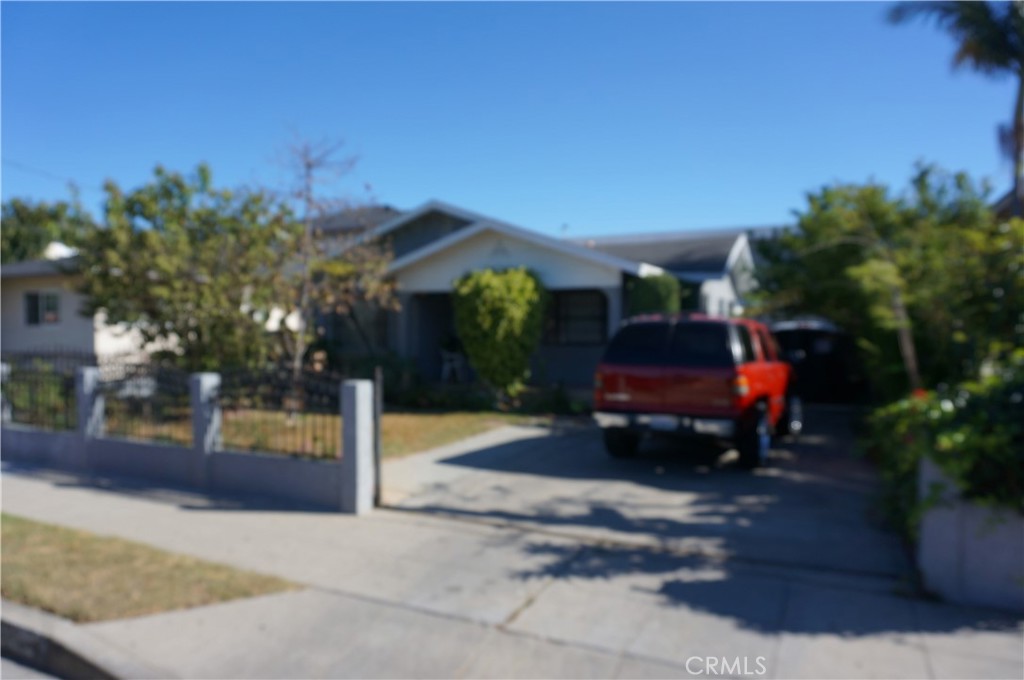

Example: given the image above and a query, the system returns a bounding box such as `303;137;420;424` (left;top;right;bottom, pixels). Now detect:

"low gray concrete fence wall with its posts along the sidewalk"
0;368;376;514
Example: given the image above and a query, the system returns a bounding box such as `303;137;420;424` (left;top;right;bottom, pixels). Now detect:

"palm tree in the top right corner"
889;0;1024;217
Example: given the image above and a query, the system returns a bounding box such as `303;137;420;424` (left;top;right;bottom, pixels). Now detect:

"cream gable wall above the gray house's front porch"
396;231;622;293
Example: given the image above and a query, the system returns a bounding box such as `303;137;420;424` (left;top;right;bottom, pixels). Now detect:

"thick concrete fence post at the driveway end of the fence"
339;380;375;515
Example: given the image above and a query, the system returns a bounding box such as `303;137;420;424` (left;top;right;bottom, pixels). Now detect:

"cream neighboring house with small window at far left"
0;257;153;359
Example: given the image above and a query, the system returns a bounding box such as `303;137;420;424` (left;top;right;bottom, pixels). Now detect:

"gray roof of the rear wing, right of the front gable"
575;229;749;275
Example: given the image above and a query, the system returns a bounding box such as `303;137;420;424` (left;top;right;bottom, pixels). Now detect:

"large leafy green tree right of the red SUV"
757;163;1024;397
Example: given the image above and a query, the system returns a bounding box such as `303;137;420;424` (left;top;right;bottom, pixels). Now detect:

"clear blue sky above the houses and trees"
0;2;1013;237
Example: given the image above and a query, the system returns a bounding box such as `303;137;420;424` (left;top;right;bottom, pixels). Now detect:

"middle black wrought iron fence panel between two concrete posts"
99;363;193;447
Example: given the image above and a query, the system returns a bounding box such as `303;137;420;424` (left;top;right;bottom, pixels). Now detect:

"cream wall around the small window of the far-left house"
0;277;95;353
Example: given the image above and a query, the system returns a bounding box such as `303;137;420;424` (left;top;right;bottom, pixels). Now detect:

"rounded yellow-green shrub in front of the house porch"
453;267;547;398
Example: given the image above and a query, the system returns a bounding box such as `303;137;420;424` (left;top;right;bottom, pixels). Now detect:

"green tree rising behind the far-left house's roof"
0;197;92;263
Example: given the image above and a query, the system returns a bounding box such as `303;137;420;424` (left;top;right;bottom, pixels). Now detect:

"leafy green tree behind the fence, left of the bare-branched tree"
79;165;300;371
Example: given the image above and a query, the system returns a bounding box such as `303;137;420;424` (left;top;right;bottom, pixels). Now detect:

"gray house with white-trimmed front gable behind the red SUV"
346;201;754;387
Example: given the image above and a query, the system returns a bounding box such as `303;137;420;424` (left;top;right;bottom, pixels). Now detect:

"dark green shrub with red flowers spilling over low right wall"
867;350;1024;537
